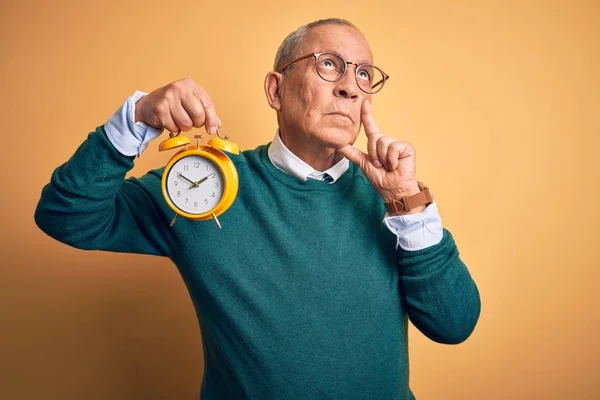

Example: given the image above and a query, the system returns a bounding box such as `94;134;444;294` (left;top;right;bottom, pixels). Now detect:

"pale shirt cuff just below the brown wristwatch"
383;201;444;251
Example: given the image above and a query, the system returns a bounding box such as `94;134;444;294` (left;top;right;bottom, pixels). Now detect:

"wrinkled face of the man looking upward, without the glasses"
279;25;373;149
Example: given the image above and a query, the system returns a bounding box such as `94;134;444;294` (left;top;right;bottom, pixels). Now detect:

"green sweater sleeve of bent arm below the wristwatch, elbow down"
397;229;481;344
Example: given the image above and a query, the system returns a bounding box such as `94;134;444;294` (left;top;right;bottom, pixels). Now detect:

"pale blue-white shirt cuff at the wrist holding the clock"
104;90;162;156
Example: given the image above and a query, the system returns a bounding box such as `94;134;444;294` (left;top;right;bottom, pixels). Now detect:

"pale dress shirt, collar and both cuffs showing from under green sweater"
104;91;443;251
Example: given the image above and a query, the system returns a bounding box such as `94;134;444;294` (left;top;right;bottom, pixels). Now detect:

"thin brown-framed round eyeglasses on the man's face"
279;52;390;94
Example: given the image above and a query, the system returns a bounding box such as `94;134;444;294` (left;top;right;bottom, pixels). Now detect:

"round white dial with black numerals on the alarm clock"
166;155;224;214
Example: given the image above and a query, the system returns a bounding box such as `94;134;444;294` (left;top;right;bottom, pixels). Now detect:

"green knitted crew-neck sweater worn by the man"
35;127;480;400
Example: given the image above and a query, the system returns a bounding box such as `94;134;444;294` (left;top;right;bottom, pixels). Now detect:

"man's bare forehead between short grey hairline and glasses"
298;24;373;64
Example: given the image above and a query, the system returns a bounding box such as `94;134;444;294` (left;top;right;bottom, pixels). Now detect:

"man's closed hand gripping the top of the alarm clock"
135;78;221;134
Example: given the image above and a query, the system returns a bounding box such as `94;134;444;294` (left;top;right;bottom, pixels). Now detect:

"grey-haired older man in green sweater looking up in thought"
35;19;480;400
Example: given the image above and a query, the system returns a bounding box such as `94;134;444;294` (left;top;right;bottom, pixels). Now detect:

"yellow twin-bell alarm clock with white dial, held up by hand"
158;129;240;229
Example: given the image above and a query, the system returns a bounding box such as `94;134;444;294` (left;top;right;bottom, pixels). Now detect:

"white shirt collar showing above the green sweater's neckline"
268;129;350;183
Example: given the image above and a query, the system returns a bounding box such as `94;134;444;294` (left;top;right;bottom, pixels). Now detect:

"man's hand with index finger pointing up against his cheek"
338;100;425;209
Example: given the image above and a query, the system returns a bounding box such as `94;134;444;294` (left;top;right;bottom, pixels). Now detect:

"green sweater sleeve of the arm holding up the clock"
34;126;174;257
